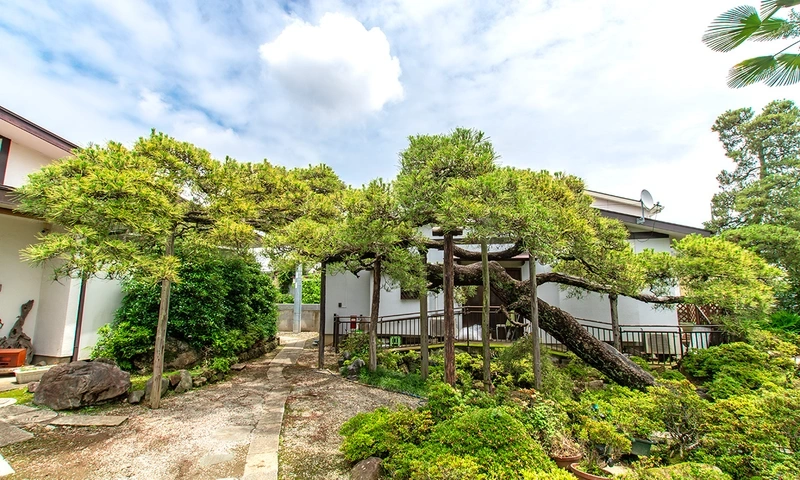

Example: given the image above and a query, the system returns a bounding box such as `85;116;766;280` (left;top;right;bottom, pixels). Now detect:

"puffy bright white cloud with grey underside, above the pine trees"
259;13;403;117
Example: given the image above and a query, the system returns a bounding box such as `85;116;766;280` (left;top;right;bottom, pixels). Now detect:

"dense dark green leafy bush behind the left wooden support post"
92;251;277;371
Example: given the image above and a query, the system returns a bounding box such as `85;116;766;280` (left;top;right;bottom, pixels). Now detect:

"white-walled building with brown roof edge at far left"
0;107;122;363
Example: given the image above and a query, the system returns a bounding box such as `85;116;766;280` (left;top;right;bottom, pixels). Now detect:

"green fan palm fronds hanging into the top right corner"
703;0;800;88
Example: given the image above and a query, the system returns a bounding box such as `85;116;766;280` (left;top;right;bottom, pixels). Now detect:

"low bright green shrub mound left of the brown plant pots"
340;384;570;479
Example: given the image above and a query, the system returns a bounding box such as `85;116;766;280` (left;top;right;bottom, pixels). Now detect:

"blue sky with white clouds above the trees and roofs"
0;0;800;226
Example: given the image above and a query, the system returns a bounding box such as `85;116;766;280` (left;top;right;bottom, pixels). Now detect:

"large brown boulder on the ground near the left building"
33;361;131;410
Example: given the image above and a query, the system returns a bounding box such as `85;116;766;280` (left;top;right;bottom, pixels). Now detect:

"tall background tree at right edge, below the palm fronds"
706;100;800;313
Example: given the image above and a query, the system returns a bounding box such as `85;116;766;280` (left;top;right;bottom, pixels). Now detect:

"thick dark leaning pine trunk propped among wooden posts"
428;262;655;390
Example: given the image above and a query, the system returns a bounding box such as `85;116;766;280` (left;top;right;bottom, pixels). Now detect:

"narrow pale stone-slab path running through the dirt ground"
242;340;305;480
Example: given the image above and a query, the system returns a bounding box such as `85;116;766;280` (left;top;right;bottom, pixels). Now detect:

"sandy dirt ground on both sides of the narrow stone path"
0;340;418;480
